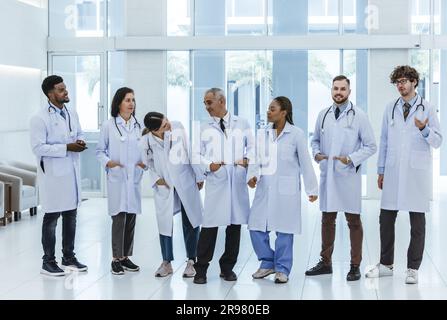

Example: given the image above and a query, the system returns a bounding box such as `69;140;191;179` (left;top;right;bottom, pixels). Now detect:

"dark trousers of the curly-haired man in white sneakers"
379;209;425;270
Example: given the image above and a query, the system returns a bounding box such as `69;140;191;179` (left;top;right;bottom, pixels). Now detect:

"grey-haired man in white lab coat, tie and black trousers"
193;88;253;284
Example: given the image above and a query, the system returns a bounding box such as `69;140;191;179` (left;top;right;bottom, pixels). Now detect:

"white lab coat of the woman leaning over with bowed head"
141;121;205;236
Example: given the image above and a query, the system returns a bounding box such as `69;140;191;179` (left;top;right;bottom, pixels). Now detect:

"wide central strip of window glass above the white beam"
167;0;368;36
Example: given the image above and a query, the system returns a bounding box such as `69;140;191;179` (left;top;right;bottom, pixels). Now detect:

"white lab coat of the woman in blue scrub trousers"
247;122;318;234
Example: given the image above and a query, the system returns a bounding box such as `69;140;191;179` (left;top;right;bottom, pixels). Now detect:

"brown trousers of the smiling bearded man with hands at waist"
320;212;363;266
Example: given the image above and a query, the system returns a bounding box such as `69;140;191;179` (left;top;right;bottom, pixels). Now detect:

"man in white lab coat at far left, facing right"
30;75;87;276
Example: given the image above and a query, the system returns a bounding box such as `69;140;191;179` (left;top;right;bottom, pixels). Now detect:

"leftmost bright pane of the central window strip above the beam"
167;0;193;36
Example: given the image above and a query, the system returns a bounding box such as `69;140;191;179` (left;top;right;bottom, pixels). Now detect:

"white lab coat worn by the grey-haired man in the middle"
196;114;254;228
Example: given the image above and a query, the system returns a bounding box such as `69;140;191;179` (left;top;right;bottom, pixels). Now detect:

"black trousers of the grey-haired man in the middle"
194;224;241;277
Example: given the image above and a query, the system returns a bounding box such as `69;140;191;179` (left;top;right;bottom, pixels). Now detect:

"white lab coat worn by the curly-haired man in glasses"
377;97;442;212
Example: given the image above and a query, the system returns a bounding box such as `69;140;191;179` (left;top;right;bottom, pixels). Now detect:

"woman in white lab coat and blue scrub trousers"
248;97;318;283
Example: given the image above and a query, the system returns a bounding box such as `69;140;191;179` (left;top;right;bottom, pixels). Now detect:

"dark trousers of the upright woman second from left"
112;212;137;258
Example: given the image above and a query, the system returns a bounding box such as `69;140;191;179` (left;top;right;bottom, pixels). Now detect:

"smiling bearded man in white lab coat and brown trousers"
306;75;377;281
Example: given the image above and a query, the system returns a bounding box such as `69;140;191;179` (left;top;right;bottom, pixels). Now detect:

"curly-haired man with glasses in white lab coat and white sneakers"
366;66;442;284
